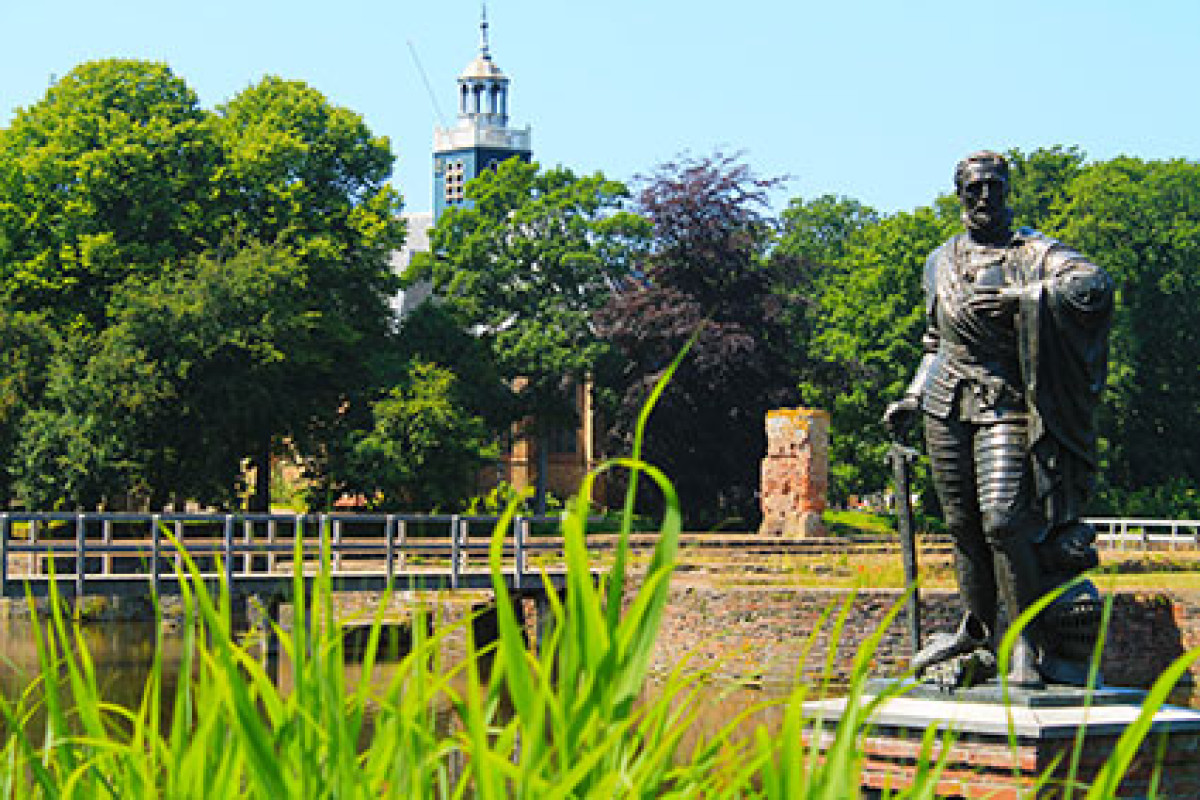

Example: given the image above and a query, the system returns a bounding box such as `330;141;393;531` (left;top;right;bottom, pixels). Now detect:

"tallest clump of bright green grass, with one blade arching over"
480;402;680;796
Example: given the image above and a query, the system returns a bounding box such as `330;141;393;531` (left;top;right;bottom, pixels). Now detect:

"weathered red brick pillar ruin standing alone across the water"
758;408;829;539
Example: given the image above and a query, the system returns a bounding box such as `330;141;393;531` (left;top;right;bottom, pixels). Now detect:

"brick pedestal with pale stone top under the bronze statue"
806;686;1200;800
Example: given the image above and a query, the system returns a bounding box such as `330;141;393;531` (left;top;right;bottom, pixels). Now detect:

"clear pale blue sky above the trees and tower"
0;0;1200;211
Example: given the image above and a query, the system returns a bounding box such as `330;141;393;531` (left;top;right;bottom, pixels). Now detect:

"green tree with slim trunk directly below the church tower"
410;158;646;507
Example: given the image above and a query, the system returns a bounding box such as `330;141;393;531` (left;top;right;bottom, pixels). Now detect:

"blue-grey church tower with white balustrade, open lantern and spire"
433;6;533;222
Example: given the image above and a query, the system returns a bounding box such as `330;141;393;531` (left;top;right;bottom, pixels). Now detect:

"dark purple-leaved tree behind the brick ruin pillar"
595;154;805;527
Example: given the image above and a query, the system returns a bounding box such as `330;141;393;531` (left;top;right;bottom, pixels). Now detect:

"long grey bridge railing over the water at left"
0;511;580;596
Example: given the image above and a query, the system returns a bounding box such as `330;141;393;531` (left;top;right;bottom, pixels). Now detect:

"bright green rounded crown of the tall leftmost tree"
0;60;222;330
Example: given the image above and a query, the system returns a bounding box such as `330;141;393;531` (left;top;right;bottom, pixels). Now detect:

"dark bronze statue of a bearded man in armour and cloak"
884;152;1114;687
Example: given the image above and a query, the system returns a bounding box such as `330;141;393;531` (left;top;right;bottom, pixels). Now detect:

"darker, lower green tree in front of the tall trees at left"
10;243;322;507
